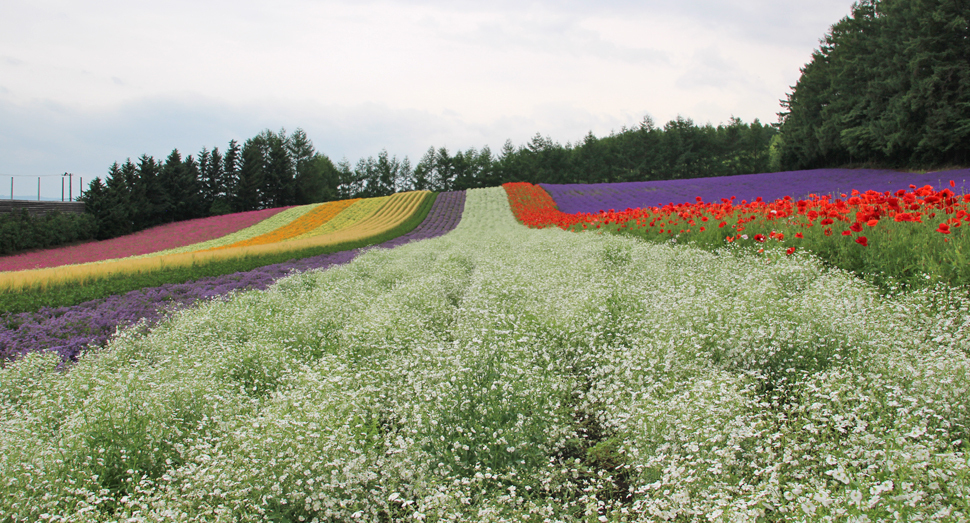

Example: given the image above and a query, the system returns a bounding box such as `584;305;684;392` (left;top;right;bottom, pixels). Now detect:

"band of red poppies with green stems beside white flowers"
504;181;970;286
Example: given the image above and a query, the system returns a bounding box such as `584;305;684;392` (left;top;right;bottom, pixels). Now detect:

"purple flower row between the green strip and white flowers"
0;191;465;362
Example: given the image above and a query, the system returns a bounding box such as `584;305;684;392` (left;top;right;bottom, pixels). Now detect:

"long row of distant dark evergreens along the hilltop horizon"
80;117;777;239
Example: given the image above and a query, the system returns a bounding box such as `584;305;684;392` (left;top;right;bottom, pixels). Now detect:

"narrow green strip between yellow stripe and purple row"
0;193;437;313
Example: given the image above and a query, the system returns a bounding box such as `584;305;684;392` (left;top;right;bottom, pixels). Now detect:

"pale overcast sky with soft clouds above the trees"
0;0;852;198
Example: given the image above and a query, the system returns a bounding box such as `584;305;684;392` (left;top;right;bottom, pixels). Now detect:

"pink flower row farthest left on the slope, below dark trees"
0;207;289;271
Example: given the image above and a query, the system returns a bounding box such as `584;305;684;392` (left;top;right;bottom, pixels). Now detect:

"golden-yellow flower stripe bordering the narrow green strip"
0;191;433;293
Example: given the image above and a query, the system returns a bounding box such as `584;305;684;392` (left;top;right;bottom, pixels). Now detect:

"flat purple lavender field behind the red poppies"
540;169;970;214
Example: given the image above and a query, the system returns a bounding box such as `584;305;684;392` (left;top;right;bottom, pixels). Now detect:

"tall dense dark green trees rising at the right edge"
777;0;970;170
